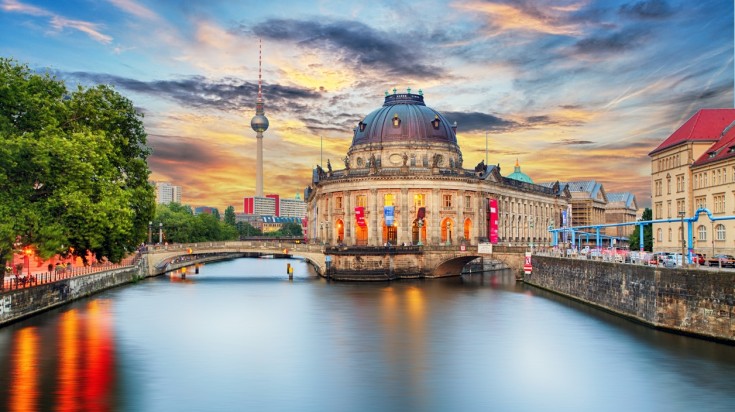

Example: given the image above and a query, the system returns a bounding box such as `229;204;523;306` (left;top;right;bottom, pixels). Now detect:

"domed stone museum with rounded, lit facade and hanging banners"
304;89;571;246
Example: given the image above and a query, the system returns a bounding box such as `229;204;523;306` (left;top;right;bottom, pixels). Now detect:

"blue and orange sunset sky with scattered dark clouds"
0;0;735;212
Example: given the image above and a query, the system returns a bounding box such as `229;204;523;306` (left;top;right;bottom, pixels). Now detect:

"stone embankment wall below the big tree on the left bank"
0;263;146;326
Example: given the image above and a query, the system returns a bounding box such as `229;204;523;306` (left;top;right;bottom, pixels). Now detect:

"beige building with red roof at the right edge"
648;109;735;256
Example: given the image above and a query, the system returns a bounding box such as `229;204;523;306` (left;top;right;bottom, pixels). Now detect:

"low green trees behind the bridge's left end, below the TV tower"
153;203;238;243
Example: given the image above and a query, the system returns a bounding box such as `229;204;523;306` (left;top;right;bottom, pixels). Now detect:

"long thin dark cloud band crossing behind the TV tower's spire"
68;72;321;110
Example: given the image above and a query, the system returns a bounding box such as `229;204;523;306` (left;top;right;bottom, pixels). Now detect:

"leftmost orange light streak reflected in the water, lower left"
9;328;38;411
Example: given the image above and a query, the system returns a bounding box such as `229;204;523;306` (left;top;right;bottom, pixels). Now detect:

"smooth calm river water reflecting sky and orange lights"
0;259;735;411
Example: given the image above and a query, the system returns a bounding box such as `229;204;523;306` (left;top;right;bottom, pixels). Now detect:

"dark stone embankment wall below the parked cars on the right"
523;255;735;344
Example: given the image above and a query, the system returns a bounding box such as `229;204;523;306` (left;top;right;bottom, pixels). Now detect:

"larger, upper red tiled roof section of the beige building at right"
648;109;735;156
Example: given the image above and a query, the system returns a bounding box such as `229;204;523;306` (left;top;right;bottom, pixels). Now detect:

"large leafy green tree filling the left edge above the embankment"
0;58;155;261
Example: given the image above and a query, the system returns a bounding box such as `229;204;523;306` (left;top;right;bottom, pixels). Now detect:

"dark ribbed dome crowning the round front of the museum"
352;89;457;147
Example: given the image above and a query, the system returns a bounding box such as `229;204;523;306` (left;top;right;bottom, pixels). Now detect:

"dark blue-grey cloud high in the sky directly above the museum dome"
250;19;444;78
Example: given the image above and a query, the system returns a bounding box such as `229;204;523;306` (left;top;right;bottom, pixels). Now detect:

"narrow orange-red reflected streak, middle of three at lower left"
56;309;80;411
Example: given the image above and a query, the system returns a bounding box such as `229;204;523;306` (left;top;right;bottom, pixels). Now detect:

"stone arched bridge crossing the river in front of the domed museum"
146;240;525;280
